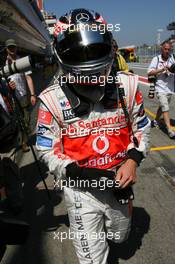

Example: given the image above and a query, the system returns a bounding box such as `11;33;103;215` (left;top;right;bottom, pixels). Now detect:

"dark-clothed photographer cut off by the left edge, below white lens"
0;80;23;214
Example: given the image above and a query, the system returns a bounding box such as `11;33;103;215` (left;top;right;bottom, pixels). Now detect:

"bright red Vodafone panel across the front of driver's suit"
63;127;130;169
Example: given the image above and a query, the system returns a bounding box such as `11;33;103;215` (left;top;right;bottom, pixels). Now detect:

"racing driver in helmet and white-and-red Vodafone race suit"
36;9;150;264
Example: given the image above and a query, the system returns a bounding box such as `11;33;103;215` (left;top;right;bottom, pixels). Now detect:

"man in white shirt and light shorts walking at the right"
148;41;175;138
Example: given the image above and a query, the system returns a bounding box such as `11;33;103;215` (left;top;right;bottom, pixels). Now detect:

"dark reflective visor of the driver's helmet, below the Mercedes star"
57;24;112;65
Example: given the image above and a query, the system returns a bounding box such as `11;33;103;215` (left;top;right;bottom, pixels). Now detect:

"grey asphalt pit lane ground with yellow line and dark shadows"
1;66;175;264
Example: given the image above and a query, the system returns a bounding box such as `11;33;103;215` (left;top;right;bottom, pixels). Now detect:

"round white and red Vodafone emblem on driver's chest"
92;136;109;154
